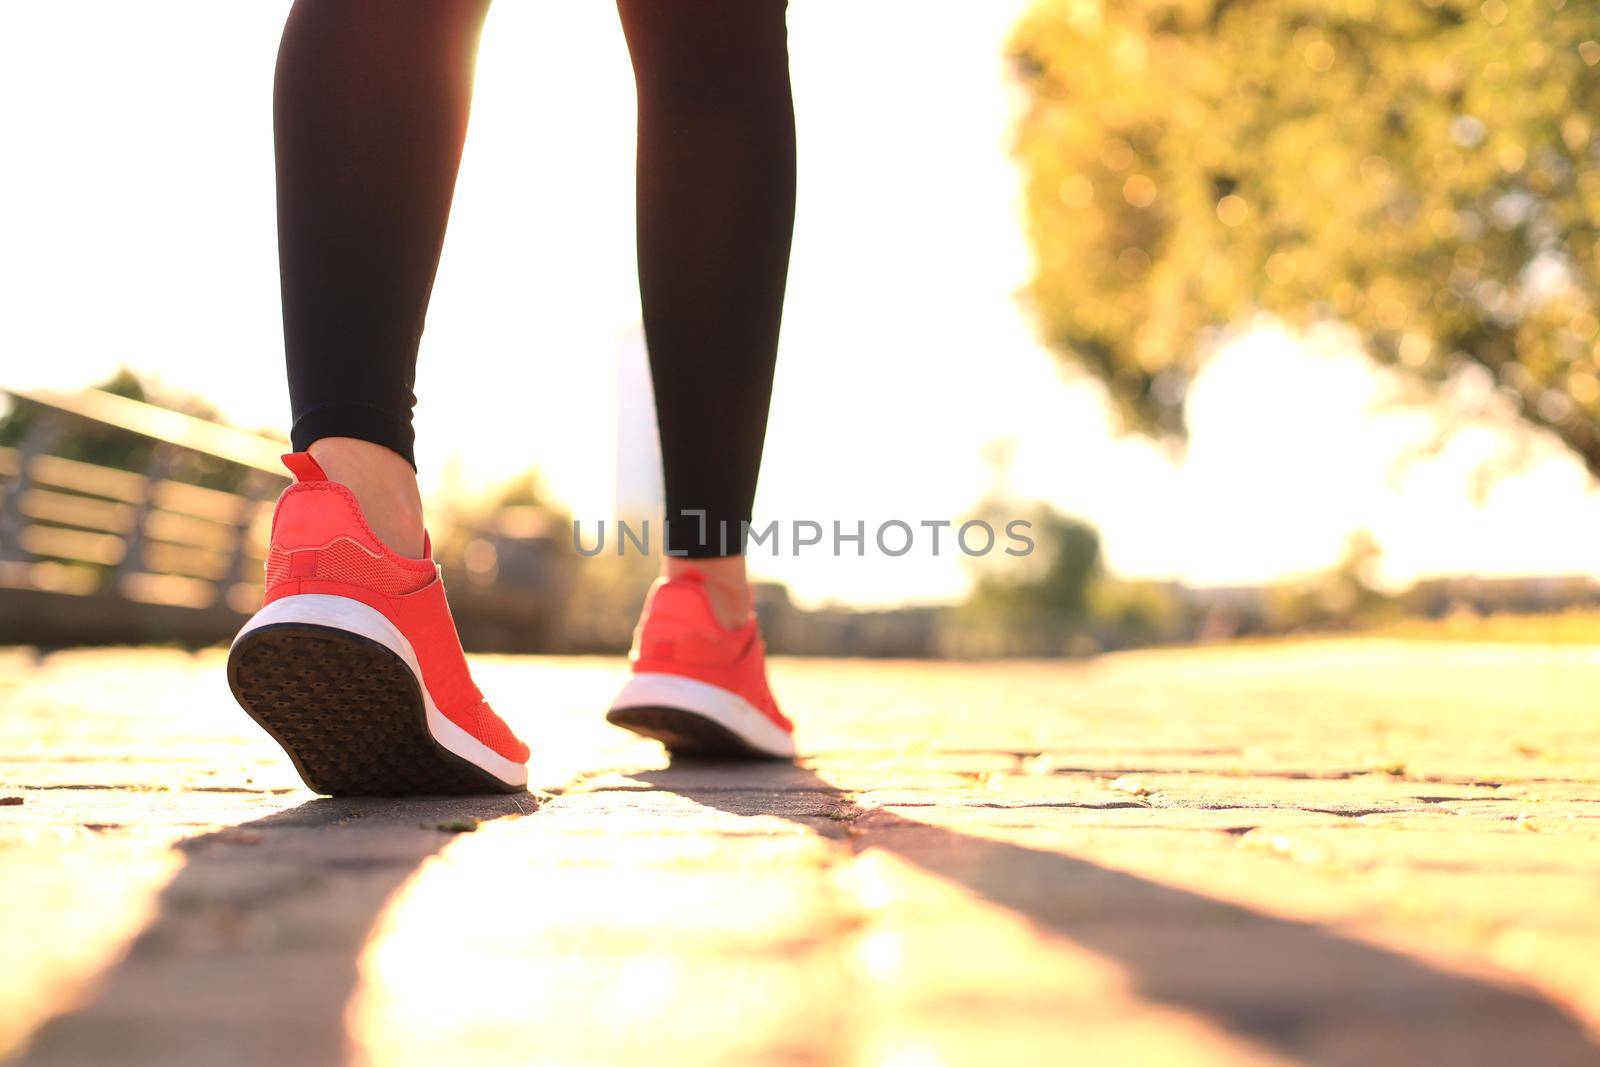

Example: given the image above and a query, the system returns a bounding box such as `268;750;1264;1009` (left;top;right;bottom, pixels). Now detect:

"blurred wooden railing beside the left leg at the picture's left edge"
0;389;288;640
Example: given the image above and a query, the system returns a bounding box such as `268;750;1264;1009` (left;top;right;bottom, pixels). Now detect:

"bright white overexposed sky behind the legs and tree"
0;0;1600;603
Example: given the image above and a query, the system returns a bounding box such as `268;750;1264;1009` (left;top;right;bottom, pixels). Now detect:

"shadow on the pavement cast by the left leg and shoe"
21;795;538;1067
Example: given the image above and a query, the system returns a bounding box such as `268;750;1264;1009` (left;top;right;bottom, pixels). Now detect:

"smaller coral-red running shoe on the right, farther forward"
606;573;795;760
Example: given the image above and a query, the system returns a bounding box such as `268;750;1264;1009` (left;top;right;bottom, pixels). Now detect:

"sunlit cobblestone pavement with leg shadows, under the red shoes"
0;641;1600;1067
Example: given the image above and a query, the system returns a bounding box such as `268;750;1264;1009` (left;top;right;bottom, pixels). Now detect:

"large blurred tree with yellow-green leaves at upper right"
1011;0;1600;475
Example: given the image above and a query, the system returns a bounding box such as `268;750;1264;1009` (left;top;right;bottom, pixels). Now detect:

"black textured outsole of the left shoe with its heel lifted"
227;622;526;797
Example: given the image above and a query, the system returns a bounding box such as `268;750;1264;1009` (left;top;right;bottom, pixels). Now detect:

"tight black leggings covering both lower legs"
274;0;795;557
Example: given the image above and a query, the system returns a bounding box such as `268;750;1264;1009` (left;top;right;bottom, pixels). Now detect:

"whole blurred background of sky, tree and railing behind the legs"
0;0;1600;656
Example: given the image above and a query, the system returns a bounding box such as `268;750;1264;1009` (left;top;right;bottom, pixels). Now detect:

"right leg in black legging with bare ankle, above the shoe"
618;0;795;616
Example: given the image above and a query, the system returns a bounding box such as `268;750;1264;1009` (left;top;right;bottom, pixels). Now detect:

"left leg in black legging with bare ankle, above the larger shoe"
274;0;488;555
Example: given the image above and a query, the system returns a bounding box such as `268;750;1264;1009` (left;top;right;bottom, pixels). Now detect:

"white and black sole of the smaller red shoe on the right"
606;673;795;760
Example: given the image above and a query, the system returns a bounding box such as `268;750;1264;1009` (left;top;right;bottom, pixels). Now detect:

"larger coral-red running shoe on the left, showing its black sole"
227;453;528;797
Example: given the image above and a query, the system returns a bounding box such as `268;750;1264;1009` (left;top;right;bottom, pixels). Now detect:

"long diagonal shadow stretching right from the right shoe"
632;765;1600;1067
